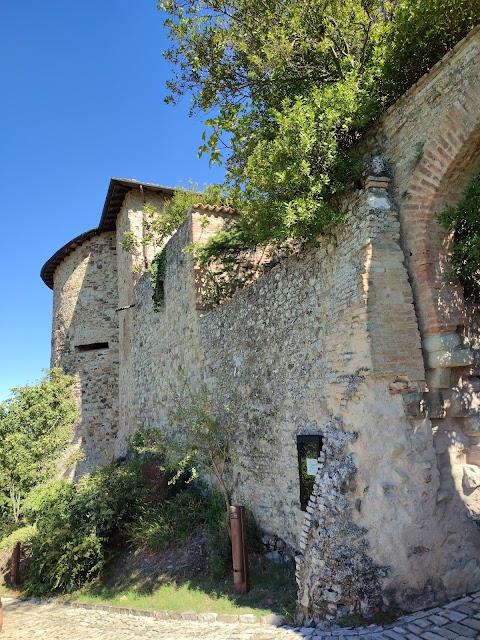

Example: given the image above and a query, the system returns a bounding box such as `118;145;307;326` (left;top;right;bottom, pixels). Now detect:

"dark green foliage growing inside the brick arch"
438;173;480;301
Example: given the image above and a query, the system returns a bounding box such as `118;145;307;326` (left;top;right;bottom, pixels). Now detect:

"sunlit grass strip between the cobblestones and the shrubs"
72;558;296;617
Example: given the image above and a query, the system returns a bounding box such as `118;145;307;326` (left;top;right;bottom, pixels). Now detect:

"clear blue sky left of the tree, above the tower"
0;0;223;400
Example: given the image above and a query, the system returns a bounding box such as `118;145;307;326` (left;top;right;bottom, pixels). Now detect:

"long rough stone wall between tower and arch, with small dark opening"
112;180;478;619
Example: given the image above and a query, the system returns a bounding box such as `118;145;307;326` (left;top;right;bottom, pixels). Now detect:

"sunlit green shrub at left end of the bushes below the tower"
25;458;170;595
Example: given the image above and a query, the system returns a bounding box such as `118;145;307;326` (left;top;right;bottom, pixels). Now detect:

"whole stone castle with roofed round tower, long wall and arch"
42;28;480;620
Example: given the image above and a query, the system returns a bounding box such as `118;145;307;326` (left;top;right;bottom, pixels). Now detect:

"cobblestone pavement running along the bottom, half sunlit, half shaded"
2;592;480;640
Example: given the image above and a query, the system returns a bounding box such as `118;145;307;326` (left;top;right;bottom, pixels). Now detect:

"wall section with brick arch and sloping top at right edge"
364;27;480;595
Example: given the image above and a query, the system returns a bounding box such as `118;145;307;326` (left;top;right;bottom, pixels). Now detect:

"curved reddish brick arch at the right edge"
402;95;480;338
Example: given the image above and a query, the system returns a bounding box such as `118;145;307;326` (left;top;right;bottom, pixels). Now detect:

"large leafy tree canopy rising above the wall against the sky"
152;0;480;260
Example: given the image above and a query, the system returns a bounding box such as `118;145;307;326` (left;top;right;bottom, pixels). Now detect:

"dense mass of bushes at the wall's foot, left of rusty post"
16;444;234;595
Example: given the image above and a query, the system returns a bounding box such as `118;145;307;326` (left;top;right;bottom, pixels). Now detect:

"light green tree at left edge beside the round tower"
0;369;77;522
